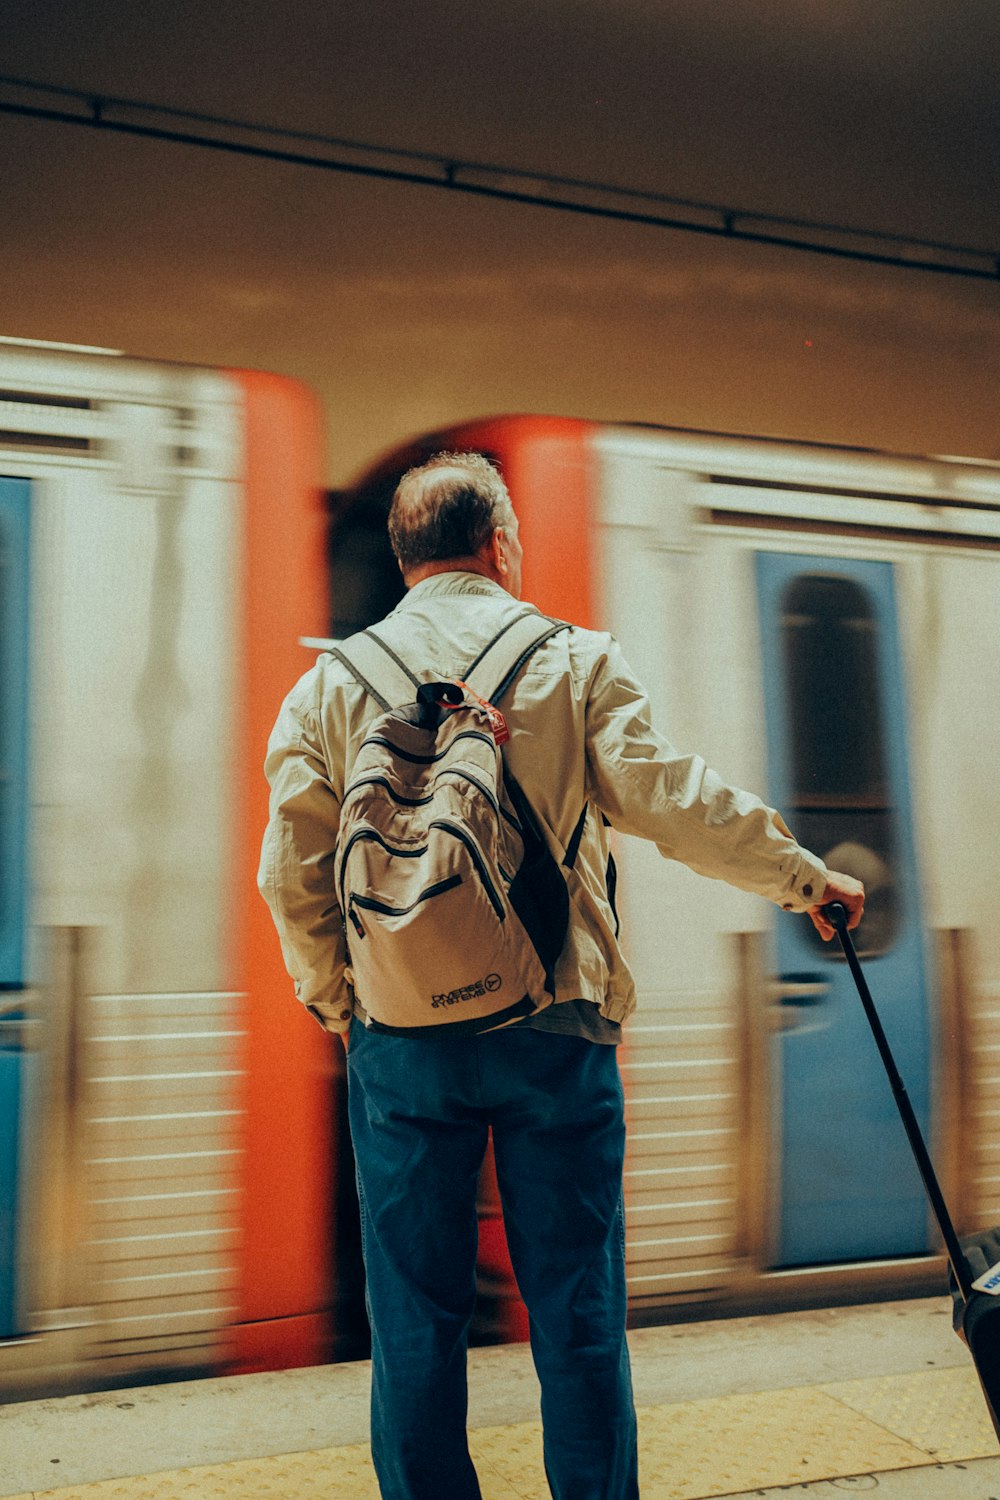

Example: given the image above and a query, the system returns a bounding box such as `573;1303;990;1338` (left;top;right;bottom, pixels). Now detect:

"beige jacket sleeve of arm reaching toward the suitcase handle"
586;638;826;912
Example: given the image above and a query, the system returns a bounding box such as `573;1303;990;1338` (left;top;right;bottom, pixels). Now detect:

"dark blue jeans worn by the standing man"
348;1020;639;1500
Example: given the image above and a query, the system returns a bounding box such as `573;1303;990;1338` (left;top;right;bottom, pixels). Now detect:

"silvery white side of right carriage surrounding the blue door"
587;429;1000;1305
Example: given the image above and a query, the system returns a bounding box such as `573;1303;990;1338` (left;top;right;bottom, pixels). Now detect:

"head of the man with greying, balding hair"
388;453;522;599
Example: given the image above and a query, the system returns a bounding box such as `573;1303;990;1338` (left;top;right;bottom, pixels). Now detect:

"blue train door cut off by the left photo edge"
0;479;30;1338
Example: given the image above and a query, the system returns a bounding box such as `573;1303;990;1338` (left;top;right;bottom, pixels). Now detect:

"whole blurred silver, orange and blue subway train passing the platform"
0;341;1000;1398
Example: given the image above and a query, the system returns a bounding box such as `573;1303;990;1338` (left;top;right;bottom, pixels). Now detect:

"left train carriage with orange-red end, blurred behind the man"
0;342;328;1394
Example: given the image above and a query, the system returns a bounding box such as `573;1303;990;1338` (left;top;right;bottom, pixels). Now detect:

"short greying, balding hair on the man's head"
388;453;513;573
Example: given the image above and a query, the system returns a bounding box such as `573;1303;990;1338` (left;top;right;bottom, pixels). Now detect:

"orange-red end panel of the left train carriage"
229;371;337;1371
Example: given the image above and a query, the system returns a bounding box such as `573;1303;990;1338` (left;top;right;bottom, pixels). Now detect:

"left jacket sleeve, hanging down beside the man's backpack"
258;668;354;1032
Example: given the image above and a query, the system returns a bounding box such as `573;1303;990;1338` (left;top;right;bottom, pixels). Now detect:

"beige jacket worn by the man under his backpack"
258;572;826;1031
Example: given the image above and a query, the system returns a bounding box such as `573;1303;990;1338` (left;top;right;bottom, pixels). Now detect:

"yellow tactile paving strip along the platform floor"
9;1367;999;1500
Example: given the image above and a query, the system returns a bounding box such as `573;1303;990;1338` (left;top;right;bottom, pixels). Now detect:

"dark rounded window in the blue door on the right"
781;573;900;957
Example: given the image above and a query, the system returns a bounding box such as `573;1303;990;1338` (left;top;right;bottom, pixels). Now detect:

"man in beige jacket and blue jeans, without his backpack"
261;455;864;1500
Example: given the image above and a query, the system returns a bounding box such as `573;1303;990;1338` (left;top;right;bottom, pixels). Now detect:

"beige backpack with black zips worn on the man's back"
333;609;568;1037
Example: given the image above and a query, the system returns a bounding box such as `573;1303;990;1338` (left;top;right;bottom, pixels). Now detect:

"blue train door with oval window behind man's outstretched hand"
756;552;931;1266
